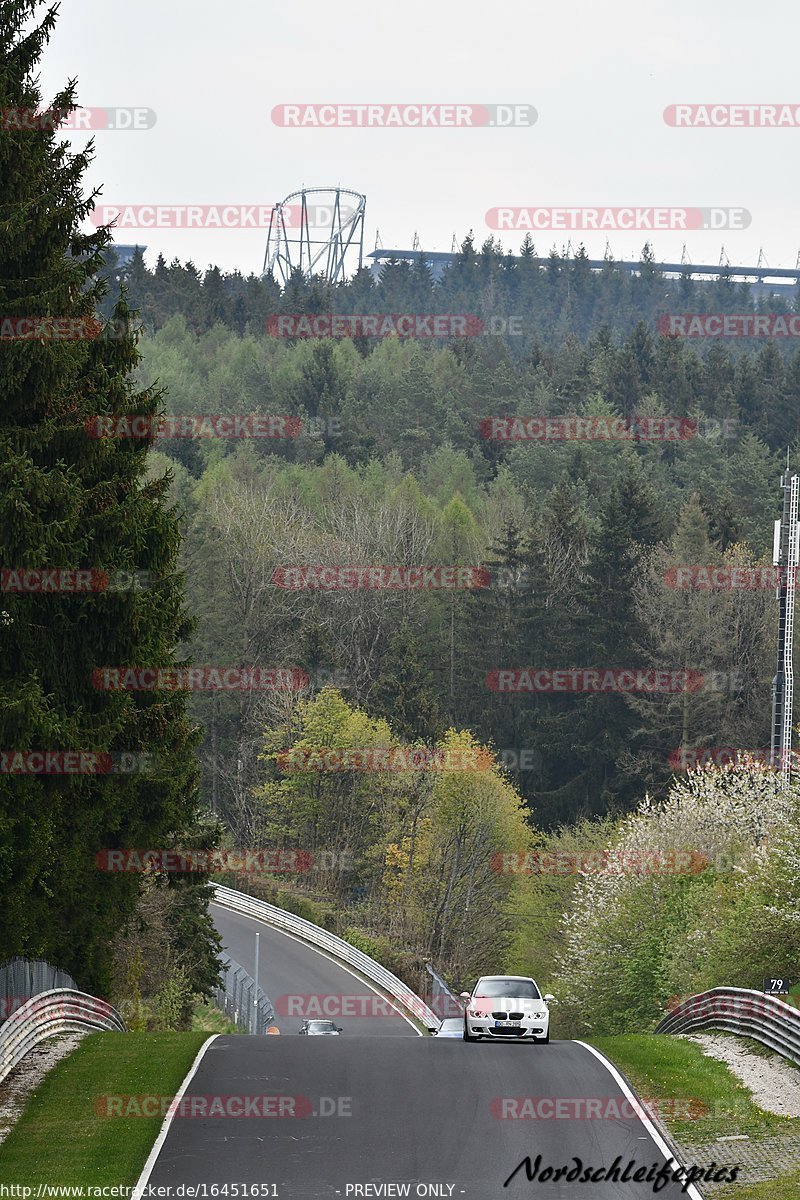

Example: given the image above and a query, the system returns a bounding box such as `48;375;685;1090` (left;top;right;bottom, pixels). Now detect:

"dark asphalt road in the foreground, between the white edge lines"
142;1037;708;1200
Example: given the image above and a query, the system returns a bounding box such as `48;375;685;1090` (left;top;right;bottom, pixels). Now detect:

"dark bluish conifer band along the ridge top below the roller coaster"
103;232;794;372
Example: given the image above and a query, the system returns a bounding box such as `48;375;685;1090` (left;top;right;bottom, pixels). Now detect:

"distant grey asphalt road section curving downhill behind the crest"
211;905;417;1040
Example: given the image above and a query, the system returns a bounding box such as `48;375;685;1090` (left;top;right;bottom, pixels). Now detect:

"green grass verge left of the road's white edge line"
0;1032;209;1186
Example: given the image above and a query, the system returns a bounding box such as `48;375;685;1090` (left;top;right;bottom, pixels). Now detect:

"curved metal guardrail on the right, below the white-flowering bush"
655;988;800;1066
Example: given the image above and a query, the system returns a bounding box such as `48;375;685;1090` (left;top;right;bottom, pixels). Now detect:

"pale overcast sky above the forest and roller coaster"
35;0;800;272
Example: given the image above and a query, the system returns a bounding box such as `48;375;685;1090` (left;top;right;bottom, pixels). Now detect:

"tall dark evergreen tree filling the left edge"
0;0;213;991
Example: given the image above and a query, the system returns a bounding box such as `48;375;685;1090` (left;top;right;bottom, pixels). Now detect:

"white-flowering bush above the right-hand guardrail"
558;761;800;1032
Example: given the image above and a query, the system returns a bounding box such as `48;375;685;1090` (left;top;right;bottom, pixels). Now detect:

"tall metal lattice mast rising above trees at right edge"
770;466;800;775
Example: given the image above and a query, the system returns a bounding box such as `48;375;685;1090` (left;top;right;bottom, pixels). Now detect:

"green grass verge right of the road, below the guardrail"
591;1033;794;1142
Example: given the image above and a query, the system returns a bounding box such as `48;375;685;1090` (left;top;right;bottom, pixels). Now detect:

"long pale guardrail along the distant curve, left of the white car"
213;883;439;1028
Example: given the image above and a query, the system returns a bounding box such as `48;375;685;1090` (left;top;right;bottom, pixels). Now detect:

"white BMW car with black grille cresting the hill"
461;976;555;1043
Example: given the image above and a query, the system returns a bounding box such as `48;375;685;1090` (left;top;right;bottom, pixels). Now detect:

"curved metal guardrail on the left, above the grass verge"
0;988;125;1082
